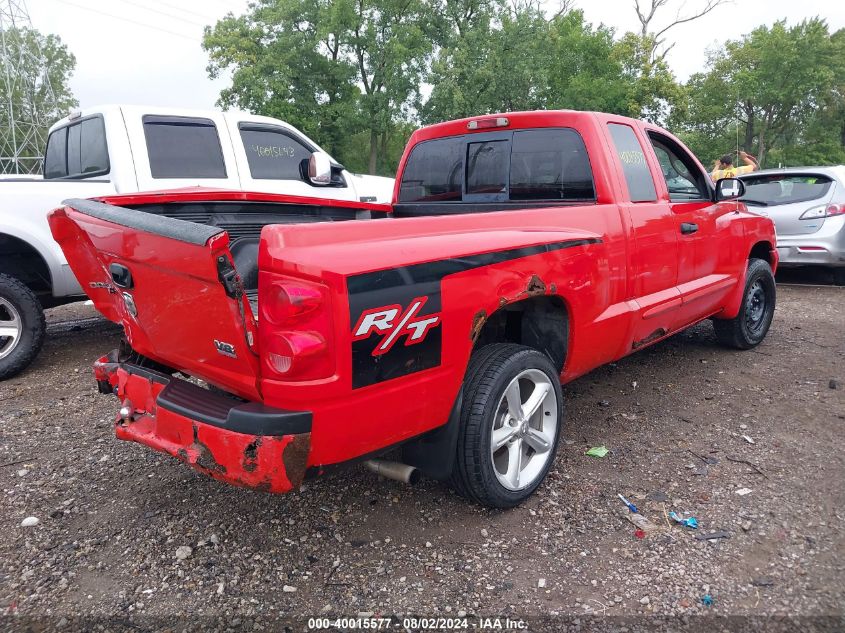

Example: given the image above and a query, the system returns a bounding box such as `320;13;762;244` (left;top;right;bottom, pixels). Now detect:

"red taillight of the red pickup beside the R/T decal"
258;273;335;380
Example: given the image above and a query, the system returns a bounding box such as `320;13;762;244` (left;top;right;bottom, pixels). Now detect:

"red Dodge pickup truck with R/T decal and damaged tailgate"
44;111;777;507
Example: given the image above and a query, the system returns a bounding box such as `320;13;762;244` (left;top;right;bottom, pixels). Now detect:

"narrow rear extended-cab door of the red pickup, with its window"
607;119;681;349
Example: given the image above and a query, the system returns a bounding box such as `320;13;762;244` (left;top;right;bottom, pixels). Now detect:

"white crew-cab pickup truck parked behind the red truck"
0;106;393;380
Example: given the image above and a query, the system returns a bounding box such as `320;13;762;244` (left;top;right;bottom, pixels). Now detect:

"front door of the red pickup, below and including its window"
647;130;736;325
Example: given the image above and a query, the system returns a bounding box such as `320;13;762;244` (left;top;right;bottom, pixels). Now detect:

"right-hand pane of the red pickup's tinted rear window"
510;129;596;200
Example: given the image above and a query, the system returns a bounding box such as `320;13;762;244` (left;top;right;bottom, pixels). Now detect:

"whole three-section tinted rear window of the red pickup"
399;128;595;203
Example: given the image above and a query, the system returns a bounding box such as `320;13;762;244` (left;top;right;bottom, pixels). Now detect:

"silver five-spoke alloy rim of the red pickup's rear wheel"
490;369;560;490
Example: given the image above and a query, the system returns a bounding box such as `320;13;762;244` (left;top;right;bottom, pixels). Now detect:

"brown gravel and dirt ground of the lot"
0;274;845;630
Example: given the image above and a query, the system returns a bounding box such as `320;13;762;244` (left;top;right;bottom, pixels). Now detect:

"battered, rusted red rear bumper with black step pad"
94;352;311;493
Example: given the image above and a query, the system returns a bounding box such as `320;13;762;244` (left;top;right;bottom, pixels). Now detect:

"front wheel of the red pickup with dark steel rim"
713;259;777;349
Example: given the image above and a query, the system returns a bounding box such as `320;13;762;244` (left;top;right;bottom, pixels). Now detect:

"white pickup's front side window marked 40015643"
240;124;314;180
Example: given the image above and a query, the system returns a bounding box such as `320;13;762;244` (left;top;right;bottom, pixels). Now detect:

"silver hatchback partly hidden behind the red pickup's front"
740;165;845;286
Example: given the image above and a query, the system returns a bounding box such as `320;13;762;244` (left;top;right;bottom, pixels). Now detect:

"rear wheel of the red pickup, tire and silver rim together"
452;344;563;508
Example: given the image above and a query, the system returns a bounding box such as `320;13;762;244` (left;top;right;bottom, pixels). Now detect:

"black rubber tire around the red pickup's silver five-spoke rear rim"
451;343;563;508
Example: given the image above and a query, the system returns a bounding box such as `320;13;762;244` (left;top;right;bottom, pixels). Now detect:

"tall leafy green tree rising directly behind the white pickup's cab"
203;0;432;173
